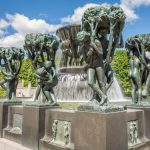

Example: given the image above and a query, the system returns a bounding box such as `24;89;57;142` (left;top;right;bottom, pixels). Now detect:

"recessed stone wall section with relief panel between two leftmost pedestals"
3;106;23;144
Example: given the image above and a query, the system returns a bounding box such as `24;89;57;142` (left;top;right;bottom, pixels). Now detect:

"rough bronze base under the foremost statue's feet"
77;101;124;113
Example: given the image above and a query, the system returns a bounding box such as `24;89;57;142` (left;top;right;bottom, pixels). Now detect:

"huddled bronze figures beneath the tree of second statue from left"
34;58;58;105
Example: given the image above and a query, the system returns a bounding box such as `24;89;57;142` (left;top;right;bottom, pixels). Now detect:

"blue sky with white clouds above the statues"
0;0;150;47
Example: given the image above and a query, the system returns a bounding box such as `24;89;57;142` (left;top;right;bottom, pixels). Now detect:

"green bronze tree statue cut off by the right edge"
126;34;150;104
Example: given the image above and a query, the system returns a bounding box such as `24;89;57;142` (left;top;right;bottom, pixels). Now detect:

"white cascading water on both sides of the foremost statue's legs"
54;68;124;102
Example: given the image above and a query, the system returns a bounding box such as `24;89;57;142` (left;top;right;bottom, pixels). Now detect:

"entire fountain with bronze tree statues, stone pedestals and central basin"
0;5;150;150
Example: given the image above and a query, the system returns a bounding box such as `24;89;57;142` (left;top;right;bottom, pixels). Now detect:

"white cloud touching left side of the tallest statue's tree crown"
61;3;98;24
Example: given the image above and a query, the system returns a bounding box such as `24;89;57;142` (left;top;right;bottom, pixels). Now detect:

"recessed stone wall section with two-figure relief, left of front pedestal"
40;110;75;150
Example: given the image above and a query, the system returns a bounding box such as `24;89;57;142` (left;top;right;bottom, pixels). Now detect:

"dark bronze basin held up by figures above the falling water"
56;25;81;67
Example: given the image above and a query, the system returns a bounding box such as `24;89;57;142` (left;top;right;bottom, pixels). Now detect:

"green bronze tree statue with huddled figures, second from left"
24;33;59;105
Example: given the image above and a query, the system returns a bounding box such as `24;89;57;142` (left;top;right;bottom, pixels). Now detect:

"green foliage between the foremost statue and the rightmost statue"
112;50;131;94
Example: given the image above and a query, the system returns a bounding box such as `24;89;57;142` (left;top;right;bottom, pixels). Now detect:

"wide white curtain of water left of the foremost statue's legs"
54;74;92;101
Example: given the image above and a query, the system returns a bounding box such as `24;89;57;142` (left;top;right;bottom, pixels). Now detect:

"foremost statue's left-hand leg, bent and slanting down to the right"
87;68;107;104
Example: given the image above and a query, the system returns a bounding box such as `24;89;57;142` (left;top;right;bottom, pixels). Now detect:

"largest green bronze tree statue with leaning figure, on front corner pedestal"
77;5;126;105
